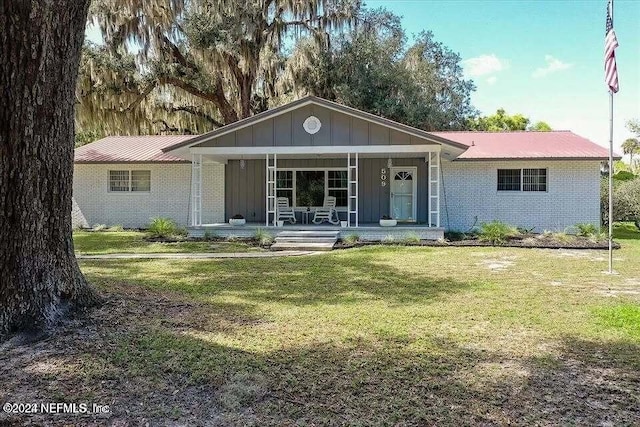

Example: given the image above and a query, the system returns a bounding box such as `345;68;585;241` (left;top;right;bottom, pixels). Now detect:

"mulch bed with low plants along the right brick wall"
335;234;620;249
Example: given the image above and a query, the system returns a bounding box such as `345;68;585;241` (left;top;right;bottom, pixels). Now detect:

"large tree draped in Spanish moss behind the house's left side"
77;0;360;138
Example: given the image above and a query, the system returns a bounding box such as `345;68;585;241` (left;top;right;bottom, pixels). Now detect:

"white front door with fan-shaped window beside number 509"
391;167;418;222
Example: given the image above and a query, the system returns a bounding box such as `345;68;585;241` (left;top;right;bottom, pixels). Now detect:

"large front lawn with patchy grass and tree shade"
0;227;640;425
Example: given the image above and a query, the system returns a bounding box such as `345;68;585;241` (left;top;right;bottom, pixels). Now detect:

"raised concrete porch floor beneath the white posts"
187;223;444;241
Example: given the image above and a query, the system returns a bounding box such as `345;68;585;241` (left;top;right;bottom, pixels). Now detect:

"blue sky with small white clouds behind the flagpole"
87;0;640;155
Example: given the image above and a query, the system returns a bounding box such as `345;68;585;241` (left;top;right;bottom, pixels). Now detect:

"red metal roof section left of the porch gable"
74;135;196;163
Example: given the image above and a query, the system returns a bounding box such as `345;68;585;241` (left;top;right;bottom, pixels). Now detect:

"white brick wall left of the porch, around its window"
73;163;224;228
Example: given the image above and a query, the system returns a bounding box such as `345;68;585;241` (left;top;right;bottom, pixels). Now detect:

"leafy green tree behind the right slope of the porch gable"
283;9;477;130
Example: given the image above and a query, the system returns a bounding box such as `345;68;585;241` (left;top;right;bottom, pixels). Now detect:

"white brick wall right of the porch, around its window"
441;160;600;232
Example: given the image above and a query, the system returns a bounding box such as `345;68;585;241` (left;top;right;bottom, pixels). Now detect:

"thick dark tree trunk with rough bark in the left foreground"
0;0;97;339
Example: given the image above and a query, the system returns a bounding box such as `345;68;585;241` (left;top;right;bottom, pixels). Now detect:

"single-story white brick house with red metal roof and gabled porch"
74;97;607;237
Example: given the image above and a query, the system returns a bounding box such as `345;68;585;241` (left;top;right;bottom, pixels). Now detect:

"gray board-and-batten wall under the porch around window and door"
225;157;428;224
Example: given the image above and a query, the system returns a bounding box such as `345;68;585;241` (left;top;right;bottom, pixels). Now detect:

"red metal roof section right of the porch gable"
431;131;617;160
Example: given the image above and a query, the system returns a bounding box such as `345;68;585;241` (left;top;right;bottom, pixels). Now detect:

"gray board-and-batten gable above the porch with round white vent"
194;105;434;147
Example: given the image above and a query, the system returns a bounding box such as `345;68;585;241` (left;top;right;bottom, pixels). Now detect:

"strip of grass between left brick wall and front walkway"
73;231;259;255
